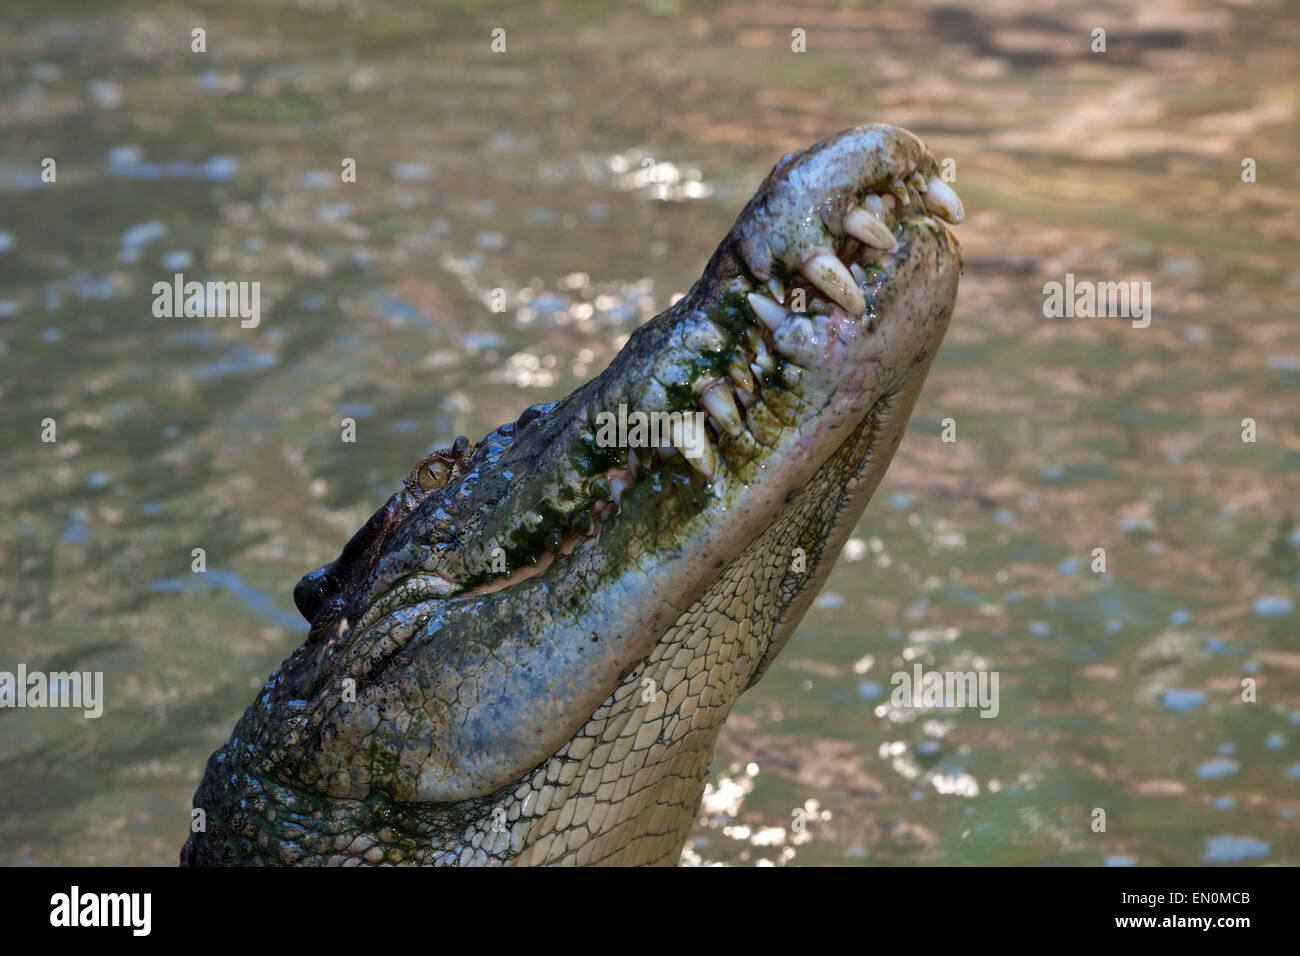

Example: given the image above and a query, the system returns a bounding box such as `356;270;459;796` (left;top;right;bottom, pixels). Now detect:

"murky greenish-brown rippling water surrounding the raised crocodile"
0;0;1300;865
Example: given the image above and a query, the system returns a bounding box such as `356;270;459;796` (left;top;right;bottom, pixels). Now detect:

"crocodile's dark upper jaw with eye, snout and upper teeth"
295;125;963;637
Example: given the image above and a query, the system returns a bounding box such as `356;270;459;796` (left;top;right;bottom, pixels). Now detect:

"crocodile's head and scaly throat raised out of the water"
182;126;962;864
